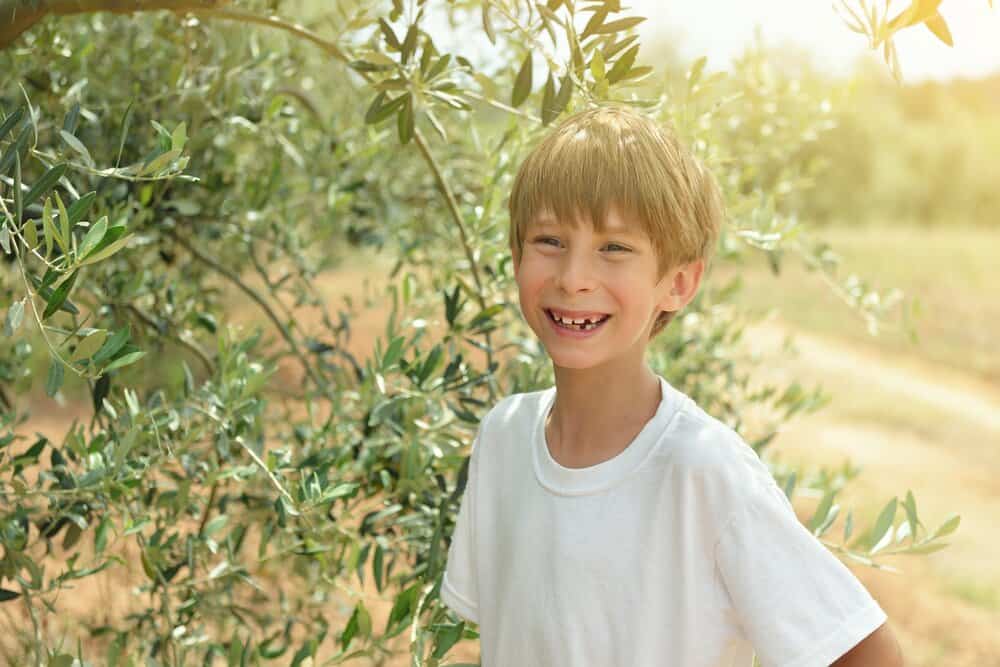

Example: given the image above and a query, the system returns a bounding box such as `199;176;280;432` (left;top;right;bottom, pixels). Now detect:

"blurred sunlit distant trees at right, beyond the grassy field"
803;70;1000;226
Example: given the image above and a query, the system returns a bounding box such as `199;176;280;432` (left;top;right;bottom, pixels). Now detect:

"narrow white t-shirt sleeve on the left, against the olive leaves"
441;430;482;623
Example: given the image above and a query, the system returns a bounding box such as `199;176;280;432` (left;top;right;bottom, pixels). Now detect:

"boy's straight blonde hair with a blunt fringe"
508;106;725;337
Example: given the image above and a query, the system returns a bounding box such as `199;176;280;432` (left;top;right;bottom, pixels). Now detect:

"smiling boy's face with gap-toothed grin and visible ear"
515;207;701;369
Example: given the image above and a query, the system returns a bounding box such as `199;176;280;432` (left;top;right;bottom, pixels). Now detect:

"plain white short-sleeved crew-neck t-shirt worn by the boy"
441;377;886;667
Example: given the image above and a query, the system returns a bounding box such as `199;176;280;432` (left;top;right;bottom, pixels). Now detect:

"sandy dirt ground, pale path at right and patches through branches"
7;264;1000;667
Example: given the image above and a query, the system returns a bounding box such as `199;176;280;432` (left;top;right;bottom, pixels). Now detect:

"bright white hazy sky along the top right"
622;0;1000;83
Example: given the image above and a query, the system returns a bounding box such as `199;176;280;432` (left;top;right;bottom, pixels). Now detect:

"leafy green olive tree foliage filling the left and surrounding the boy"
0;0;957;665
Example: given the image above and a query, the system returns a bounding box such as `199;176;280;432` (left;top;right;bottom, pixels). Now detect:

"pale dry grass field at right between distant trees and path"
720;224;1000;382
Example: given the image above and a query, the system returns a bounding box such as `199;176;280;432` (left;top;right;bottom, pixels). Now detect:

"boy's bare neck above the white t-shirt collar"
545;363;662;468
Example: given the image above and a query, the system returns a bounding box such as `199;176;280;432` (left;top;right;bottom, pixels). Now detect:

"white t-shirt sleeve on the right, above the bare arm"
716;480;887;667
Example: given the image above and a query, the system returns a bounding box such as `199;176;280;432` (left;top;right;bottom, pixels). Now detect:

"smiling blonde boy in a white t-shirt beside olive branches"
441;107;902;667
